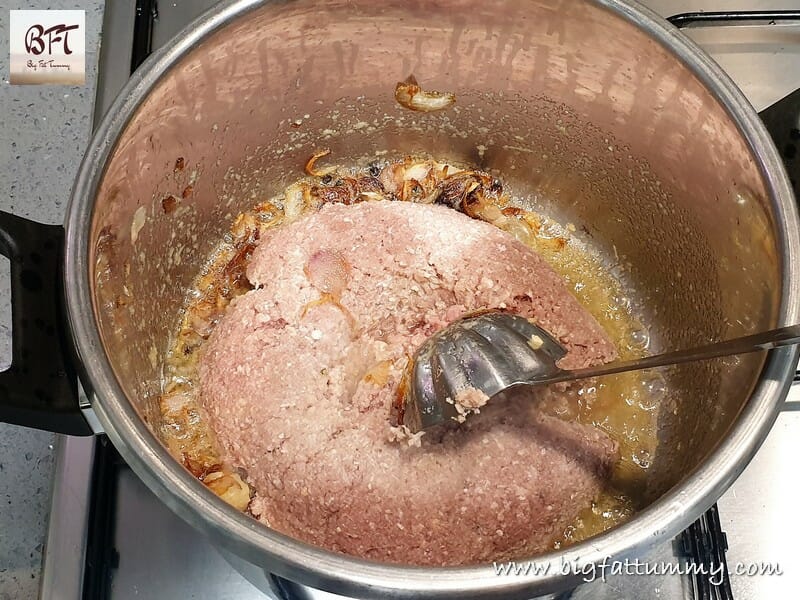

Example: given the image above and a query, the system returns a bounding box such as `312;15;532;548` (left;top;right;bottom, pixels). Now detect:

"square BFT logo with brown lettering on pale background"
9;10;86;85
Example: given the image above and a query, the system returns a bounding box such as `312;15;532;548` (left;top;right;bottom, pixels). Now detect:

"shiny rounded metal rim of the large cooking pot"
64;0;800;598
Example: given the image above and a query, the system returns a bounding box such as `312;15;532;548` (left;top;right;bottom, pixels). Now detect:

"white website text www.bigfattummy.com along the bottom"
493;557;783;585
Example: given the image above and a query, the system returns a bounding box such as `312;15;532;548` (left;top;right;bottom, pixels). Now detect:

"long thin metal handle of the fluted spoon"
560;325;800;381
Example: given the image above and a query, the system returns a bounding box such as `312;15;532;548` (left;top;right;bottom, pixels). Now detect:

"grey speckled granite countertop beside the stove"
0;0;103;600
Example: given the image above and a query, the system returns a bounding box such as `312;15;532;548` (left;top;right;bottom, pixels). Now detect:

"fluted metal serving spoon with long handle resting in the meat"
402;312;800;433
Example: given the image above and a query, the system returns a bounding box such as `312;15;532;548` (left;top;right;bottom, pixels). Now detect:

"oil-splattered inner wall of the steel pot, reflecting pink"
90;0;781;516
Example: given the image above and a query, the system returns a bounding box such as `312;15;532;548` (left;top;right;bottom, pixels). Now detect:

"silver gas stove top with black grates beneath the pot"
41;0;800;600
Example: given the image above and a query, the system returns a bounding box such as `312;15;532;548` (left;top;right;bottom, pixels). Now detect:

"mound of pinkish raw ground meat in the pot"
199;201;617;565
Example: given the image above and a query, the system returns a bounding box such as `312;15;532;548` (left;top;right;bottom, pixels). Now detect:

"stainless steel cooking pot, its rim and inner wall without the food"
0;0;800;598
